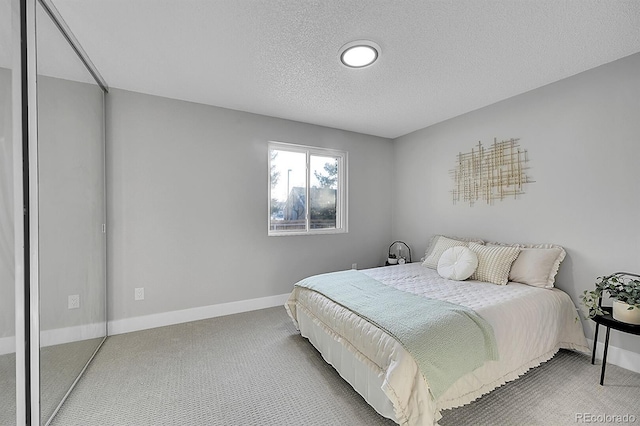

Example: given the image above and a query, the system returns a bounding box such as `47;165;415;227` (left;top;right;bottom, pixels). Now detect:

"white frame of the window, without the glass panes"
267;141;349;236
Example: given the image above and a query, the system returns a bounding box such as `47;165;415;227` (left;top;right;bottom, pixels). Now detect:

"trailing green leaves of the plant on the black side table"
580;272;640;318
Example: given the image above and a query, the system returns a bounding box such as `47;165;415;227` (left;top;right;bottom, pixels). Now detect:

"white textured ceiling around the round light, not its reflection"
54;0;640;138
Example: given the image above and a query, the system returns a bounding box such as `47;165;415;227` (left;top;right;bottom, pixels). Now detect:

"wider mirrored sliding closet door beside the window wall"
36;2;106;424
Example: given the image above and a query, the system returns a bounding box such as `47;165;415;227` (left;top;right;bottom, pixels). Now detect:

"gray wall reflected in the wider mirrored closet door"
38;75;106;337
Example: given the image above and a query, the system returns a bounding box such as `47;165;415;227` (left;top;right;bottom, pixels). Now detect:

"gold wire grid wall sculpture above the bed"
449;138;535;206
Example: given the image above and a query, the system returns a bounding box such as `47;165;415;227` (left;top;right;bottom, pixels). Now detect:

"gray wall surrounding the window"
107;89;393;321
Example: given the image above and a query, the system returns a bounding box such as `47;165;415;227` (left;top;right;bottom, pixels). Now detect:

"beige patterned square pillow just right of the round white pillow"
469;242;520;285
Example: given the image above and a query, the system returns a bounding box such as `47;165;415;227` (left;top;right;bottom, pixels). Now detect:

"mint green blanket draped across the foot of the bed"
296;270;498;399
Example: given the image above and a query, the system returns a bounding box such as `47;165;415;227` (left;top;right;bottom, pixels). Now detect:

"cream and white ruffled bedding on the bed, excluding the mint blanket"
285;263;589;425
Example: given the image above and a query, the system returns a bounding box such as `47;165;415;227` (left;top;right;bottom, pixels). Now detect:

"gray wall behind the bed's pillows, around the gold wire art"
393;54;640;353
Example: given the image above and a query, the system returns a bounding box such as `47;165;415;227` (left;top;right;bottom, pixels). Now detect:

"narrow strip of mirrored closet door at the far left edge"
0;0;16;425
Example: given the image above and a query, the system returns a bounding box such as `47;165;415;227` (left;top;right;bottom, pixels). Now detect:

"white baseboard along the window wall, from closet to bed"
109;293;289;336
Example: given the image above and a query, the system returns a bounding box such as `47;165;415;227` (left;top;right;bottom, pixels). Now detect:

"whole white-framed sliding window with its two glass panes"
269;142;347;235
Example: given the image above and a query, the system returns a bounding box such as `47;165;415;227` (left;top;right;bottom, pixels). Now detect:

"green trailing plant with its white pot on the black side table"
580;272;640;324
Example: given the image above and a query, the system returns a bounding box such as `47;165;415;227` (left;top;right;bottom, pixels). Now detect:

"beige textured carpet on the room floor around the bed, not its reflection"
52;307;640;426
